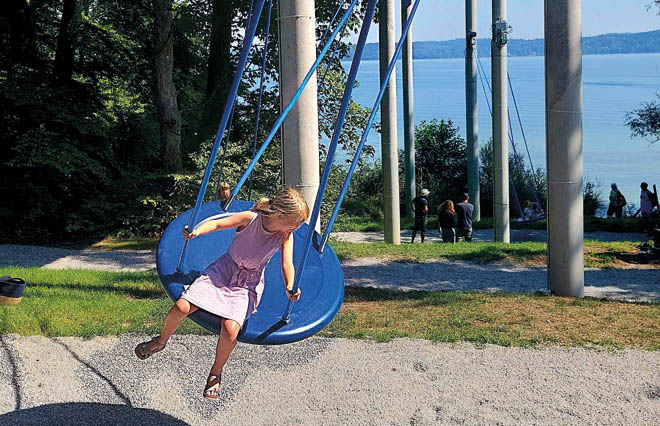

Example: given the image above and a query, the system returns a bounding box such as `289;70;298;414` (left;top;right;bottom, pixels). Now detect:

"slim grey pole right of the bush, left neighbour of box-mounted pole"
465;0;481;222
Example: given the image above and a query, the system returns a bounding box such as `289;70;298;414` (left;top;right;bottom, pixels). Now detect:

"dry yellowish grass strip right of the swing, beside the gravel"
321;288;660;350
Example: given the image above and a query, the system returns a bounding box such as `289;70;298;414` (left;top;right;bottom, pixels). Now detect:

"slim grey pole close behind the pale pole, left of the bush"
401;0;416;217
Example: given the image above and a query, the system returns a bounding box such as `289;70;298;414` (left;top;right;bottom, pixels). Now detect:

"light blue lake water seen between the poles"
346;53;660;205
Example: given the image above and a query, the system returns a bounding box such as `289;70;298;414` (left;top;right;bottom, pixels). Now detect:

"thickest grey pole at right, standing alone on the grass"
544;0;584;297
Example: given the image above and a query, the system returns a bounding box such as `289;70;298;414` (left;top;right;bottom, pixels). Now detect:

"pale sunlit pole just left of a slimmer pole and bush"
378;0;401;245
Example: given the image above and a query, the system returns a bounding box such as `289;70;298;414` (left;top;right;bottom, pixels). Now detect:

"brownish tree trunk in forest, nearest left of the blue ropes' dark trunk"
153;0;182;170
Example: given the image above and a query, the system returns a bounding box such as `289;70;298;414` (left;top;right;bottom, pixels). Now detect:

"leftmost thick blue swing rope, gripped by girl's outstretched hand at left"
177;0;265;270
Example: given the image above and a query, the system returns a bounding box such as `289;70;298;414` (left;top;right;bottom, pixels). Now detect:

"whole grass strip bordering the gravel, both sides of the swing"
0;267;660;350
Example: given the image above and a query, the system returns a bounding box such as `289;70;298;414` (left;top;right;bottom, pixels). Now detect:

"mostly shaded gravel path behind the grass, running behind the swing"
0;245;660;301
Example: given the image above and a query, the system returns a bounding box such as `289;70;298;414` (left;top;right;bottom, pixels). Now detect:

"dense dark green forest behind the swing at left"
0;0;378;241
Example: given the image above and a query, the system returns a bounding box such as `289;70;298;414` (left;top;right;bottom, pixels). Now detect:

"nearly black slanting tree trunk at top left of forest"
52;0;81;86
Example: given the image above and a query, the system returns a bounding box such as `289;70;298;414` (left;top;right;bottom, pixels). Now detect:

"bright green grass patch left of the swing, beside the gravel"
0;267;202;337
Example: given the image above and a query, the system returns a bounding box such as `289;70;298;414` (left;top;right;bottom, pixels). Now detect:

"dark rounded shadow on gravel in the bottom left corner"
0;402;188;426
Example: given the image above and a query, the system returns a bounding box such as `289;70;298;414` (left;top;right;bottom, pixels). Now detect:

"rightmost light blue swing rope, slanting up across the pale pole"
318;0;420;250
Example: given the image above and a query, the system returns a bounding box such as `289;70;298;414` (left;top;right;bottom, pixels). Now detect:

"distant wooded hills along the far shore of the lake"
354;30;660;60
